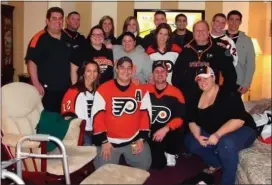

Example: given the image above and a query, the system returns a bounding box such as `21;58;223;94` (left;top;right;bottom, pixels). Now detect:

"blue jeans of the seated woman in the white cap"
185;126;257;184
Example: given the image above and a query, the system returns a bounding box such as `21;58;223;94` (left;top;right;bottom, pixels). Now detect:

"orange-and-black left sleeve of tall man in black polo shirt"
25;30;46;64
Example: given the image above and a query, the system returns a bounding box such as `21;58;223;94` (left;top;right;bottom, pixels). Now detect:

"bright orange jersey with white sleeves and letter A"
91;80;152;144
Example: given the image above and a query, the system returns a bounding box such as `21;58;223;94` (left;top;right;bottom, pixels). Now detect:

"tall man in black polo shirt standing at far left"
25;7;73;112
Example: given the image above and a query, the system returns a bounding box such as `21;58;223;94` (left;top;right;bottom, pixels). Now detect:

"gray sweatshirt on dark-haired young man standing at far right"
235;31;255;87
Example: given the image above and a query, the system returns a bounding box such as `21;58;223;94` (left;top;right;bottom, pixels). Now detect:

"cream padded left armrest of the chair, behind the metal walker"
2;134;40;149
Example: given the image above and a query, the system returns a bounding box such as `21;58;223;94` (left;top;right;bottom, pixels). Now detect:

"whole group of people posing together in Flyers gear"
25;7;256;184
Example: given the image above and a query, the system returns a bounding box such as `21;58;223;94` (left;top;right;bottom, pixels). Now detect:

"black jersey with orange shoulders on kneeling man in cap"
144;84;185;130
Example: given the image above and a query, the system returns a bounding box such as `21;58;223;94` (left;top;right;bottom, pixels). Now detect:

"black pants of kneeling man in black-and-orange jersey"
149;127;180;169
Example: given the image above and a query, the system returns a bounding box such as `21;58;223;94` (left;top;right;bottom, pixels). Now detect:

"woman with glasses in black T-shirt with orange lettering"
85;25;114;84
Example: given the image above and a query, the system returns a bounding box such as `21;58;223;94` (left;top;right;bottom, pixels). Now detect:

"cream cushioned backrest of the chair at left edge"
2;82;43;135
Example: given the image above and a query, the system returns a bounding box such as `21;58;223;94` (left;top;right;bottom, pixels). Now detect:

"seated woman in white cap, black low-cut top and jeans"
185;67;256;184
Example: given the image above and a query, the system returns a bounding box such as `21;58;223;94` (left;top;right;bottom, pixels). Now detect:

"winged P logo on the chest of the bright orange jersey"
112;97;137;116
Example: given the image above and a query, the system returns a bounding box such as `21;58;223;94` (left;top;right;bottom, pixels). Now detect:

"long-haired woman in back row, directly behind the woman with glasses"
99;15;116;49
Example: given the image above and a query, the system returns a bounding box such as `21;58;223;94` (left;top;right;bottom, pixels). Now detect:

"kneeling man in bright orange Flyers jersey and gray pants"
90;57;152;170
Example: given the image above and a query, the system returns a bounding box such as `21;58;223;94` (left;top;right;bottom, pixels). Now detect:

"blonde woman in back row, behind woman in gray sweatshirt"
117;16;143;45
